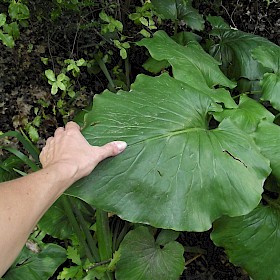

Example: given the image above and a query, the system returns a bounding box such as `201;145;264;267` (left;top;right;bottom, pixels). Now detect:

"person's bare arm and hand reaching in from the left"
0;122;126;277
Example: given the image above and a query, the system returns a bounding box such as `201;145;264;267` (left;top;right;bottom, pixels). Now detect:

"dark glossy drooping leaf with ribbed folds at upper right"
210;20;275;81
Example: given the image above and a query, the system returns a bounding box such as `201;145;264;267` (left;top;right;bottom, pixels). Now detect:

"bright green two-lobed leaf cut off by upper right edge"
253;46;280;111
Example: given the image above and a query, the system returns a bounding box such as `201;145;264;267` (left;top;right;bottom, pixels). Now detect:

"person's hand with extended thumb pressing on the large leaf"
40;122;127;183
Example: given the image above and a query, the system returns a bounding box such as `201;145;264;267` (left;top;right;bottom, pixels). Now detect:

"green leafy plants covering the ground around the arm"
1;0;280;280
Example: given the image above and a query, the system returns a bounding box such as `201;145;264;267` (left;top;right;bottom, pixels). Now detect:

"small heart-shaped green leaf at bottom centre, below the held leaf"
116;226;185;280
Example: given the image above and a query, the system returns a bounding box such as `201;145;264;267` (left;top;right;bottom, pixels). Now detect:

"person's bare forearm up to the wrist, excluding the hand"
0;166;74;277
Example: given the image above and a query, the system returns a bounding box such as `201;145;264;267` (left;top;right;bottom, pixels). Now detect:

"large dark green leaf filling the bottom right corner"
211;205;280;280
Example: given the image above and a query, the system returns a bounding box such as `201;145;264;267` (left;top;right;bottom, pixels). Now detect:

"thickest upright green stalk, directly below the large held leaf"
96;209;113;280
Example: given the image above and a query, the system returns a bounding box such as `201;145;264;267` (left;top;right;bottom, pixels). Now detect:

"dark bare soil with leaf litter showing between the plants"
0;0;280;280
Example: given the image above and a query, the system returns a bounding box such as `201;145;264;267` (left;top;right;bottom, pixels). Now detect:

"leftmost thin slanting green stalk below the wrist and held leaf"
61;195;94;263
